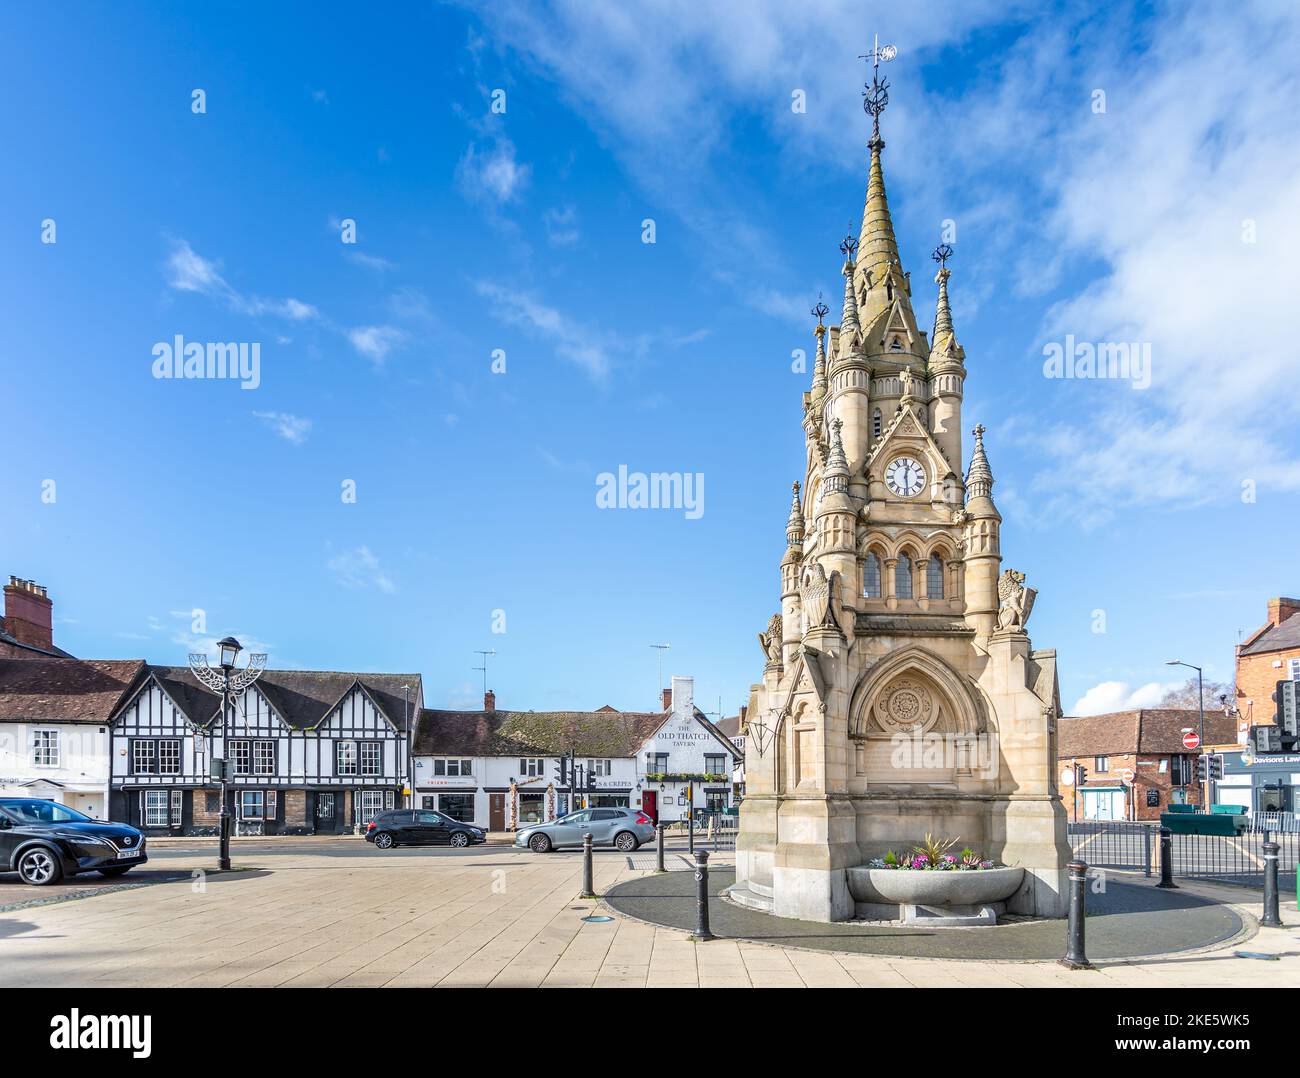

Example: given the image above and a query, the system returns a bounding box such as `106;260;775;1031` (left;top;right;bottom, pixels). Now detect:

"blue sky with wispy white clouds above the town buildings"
0;0;1300;714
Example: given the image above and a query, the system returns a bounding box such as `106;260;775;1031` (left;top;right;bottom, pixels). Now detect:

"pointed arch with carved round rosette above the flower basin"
849;645;992;739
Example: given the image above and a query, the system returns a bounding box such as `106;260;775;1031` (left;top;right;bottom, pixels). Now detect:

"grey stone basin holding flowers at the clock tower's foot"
846;867;1024;927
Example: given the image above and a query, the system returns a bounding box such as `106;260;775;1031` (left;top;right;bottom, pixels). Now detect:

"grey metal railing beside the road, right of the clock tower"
1067;821;1300;891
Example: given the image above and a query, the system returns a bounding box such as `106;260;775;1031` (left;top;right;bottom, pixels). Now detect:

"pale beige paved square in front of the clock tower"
0;839;1300;988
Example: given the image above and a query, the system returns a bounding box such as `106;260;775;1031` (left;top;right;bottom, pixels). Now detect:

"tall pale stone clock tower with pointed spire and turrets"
731;53;1070;921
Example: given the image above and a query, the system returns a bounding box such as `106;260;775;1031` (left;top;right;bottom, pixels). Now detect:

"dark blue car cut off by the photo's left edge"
0;797;150;887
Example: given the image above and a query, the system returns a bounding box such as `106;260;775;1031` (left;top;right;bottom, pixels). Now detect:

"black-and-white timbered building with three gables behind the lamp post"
109;666;423;835
